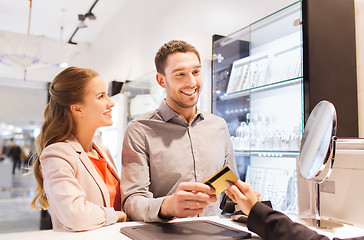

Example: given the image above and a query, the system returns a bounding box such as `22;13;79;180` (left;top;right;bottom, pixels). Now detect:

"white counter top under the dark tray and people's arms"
0;216;364;240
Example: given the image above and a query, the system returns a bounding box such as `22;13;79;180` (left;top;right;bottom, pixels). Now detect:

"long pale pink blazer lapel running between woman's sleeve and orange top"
66;136;110;207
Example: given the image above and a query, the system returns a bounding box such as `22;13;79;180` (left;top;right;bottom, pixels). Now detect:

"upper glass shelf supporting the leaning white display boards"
219;77;303;100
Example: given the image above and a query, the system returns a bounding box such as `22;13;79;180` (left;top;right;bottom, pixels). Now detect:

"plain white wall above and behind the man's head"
72;0;295;111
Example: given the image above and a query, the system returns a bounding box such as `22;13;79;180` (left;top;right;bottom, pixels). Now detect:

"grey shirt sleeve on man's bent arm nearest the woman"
121;121;165;222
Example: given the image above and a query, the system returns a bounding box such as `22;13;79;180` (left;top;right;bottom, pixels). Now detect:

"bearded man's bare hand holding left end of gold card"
160;182;217;218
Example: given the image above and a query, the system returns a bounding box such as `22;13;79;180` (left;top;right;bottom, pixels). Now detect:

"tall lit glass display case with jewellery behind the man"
212;1;304;212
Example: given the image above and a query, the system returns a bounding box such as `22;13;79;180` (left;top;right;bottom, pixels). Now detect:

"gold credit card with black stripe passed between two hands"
203;165;238;195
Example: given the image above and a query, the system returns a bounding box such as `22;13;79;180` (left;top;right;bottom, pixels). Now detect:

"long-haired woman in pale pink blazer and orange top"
31;67;126;231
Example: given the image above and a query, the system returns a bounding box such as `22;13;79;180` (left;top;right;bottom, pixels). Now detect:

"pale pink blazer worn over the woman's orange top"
40;135;122;231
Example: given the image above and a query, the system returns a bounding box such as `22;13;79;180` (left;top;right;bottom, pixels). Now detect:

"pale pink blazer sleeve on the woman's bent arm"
40;143;117;231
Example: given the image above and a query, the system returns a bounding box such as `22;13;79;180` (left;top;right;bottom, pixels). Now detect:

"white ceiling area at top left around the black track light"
0;0;126;43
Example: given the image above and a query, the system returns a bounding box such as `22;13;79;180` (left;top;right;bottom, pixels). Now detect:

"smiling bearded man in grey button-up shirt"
121;40;237;222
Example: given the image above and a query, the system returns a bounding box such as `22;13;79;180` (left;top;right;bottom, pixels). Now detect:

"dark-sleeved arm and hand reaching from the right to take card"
226;180;364;240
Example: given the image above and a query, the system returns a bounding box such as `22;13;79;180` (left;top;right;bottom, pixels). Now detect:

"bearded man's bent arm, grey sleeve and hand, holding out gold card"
121;121;217;222
